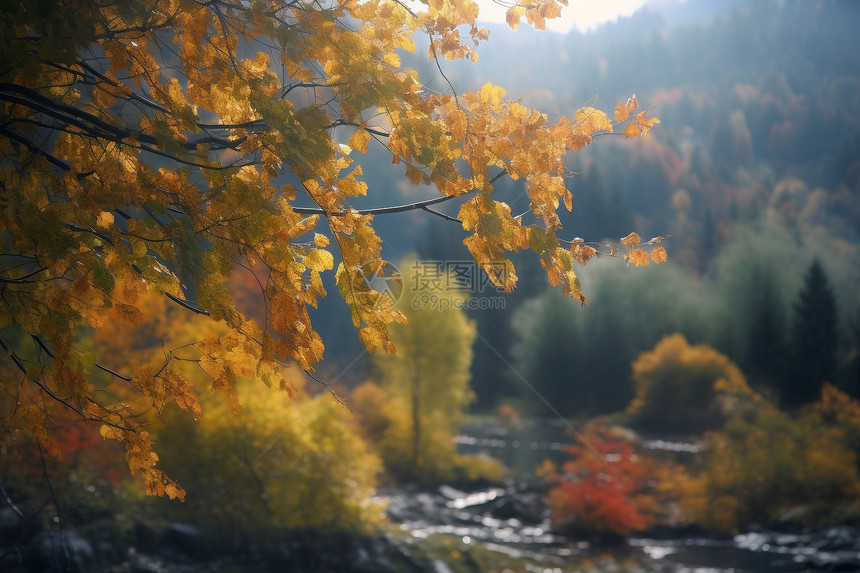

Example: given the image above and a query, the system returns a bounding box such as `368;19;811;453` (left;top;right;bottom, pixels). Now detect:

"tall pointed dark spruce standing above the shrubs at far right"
782;259;839;406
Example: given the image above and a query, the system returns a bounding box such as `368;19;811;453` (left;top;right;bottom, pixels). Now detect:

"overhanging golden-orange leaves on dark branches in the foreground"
0;0;664;497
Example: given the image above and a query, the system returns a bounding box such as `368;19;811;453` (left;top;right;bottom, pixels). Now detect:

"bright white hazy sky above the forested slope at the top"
476;0;648;33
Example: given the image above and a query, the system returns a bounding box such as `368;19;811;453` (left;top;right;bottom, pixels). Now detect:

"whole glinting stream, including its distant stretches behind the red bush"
378;420;860;573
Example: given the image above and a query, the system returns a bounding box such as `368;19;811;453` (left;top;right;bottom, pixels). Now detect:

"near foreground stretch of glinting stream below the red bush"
387;486;860;573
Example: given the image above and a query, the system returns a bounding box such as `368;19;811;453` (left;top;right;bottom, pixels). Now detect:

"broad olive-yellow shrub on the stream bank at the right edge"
692;388;860;534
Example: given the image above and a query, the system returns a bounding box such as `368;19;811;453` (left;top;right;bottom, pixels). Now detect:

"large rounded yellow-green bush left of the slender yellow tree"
153;370;381;537
